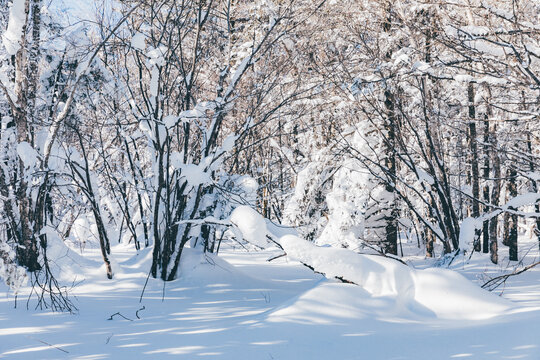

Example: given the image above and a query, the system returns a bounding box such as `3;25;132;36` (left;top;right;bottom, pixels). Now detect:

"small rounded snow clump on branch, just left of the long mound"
230;205;268;247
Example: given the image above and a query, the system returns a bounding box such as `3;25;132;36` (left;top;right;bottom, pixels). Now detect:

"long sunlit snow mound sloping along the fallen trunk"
280;235;513;320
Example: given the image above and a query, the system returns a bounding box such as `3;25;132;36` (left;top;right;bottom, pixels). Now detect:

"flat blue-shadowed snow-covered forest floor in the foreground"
0;231;540;360
